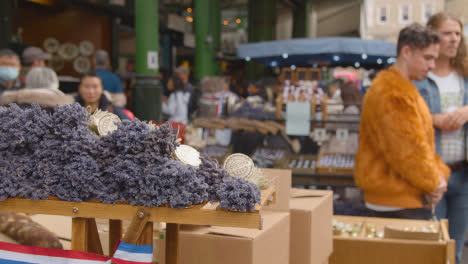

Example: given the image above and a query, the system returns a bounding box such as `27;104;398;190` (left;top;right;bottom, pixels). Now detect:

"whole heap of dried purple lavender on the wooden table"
0;103;260;211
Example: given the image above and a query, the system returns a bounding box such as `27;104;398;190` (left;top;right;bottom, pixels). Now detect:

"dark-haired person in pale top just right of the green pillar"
162;76;190;124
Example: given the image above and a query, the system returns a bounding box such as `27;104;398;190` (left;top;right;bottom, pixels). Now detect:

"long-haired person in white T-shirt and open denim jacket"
416;13;468;263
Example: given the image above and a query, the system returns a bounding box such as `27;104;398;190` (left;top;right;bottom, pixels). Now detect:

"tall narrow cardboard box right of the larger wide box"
289;189;333;264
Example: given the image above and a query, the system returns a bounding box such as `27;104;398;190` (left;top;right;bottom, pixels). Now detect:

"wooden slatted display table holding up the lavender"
0;188;276;264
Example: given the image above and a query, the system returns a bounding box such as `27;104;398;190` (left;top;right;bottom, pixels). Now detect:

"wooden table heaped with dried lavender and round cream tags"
0;104;276;263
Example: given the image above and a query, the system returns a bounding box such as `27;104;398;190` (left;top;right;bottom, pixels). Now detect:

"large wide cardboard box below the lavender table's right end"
155;212;290;264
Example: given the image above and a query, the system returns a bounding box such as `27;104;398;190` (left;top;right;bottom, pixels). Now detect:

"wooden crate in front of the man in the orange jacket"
329;216;455;264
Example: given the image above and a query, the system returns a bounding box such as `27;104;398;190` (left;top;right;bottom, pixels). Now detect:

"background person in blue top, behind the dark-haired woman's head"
93;50;127;107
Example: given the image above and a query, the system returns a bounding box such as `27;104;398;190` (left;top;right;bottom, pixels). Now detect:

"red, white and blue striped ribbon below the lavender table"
0;242;153;264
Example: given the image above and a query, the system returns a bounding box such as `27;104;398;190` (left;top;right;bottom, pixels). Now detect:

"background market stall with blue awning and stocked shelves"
225;37;396;186
